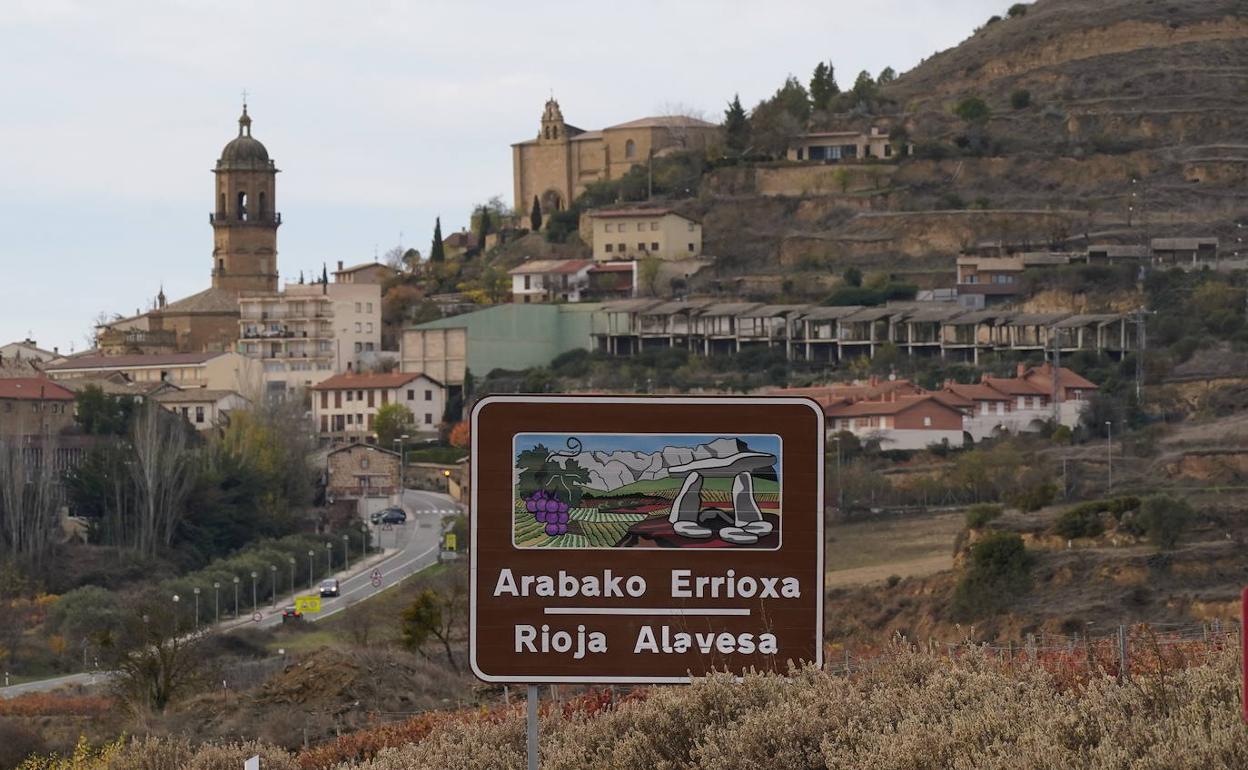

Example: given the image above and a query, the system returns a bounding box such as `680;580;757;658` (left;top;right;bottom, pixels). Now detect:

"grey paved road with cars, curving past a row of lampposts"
0;489;463;698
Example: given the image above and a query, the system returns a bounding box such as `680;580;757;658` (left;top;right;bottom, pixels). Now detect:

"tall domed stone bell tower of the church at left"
208;102;282;293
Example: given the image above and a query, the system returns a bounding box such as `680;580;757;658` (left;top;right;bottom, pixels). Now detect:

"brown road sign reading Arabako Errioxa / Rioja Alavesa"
469;396;825;683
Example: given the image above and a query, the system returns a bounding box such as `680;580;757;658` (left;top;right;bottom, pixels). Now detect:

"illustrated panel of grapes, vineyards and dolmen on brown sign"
512;433;784;549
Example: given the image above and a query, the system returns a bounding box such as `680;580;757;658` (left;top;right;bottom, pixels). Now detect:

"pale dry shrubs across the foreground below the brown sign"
337;649;1248;770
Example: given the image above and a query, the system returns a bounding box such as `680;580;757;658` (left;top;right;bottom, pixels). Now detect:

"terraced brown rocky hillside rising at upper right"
685;0;1248;298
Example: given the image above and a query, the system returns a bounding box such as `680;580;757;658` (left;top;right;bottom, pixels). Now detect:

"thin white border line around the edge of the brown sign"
468;394;827;684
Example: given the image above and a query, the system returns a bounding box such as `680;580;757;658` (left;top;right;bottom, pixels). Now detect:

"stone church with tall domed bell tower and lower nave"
96;104;282;354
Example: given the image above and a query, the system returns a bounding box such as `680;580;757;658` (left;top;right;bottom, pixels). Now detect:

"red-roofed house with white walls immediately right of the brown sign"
824;393;963;449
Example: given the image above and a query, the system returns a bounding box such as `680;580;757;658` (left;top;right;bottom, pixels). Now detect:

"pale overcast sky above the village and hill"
0;0;1008;351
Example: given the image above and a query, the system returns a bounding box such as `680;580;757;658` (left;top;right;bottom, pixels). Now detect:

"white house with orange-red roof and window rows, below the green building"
312;372;447;441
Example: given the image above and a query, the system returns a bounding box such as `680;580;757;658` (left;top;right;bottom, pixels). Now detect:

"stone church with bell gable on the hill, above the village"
512;99;719;218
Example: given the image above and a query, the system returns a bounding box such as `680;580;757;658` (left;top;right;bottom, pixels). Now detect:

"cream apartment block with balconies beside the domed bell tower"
238;283;382;393
